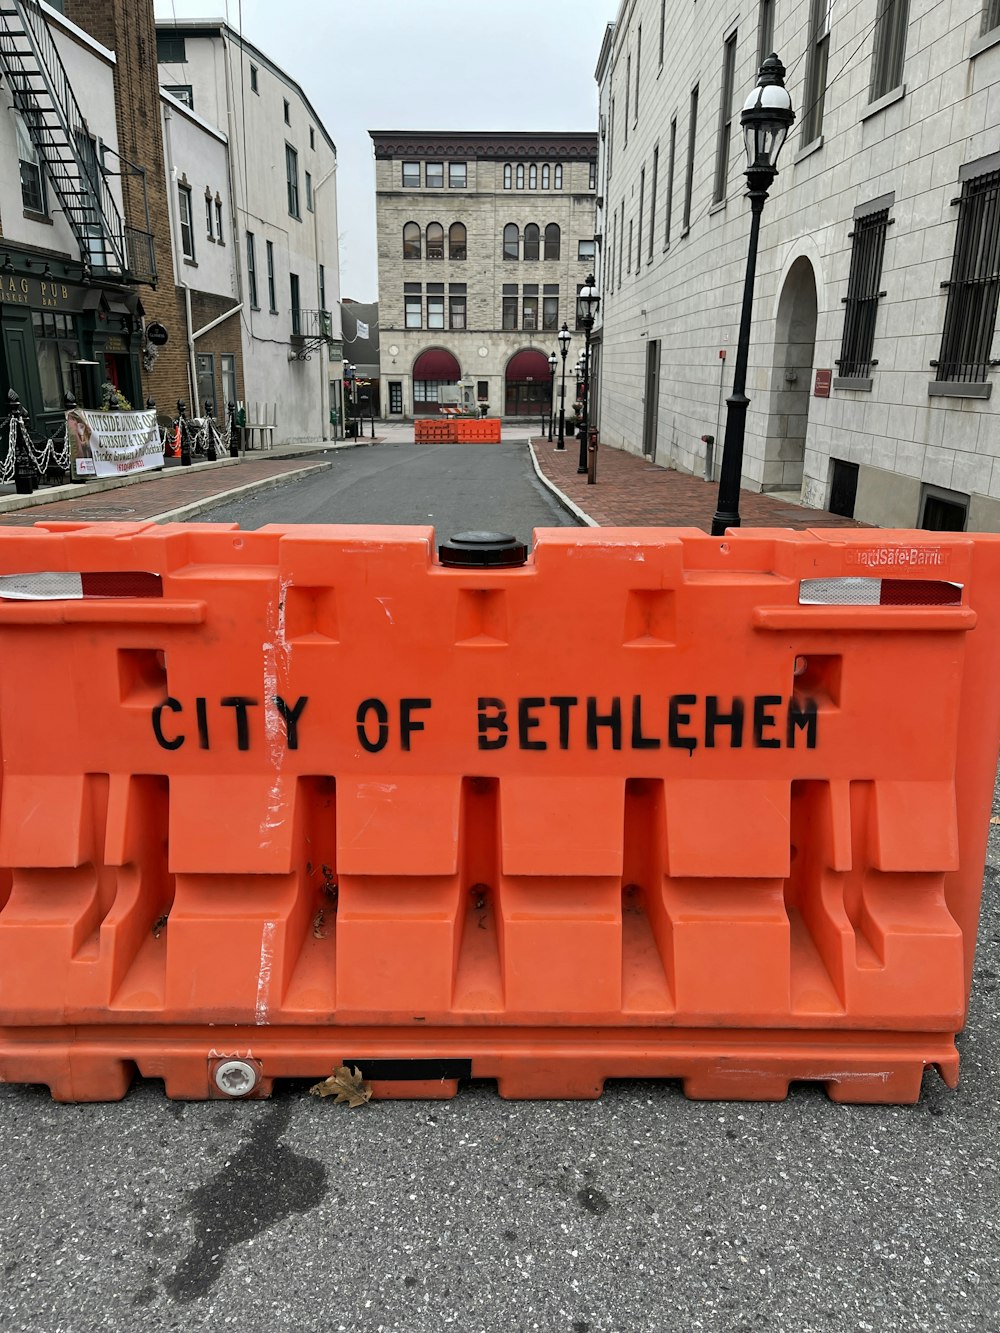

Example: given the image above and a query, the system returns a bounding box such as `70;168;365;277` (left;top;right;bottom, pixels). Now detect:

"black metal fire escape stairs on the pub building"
0;0;156;285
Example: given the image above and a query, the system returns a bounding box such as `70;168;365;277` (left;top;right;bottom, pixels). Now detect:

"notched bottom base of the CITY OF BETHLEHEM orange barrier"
0;1025;959;1104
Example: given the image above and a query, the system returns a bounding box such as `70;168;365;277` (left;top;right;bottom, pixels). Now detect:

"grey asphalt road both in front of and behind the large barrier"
0;447;1000;1333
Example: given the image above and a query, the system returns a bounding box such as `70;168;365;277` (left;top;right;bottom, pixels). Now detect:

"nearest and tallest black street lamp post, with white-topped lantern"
712;52;795;537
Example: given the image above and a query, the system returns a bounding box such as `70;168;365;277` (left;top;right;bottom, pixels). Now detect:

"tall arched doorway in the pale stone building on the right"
761;255;817;491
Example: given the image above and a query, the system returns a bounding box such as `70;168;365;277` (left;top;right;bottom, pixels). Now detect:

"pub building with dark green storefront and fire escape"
0;0;154;435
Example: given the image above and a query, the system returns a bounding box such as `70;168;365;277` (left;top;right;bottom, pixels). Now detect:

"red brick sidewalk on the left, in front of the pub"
0;457;333;528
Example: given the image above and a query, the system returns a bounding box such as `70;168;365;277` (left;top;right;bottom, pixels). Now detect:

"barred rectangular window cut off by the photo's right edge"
937;167;1000;384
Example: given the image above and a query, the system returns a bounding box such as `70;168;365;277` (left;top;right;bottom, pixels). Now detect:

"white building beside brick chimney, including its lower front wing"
156;20;341;443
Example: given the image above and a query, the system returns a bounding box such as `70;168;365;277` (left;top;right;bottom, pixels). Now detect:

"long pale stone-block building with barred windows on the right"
597;0;1000;531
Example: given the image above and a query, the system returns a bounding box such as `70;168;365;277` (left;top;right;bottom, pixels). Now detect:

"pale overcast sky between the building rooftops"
155;0;619;301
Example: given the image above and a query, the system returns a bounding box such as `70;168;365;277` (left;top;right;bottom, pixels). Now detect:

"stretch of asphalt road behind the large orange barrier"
189;444;576;543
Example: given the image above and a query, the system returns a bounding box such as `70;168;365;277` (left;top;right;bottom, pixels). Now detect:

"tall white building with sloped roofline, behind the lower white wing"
156;20;341;443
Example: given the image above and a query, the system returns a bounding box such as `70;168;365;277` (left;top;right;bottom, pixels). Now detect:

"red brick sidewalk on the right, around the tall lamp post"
531;436;861;532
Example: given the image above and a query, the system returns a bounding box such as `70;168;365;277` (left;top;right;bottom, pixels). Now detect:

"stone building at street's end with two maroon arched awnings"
371;131;597;417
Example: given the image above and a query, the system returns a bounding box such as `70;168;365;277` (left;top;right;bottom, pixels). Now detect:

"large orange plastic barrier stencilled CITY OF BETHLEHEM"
0;524;1000;1101
